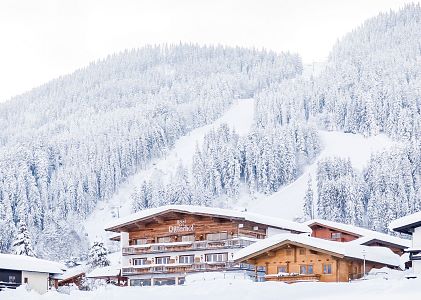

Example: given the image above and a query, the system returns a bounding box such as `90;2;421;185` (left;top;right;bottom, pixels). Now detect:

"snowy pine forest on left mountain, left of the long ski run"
0;45;302;258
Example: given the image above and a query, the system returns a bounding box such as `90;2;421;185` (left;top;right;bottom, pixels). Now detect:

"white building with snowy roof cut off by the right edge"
389;211;421;275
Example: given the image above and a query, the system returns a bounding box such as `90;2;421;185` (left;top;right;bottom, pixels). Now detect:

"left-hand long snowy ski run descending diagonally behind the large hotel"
85;99;254;241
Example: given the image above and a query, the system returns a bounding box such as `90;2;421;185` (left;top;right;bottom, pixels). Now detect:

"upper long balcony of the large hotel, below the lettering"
122;238;254;255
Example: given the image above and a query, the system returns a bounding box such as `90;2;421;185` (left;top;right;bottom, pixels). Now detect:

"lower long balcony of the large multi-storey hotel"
122;262;254;276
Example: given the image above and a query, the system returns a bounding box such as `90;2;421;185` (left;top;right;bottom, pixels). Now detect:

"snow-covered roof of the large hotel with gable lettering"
105;205;311;233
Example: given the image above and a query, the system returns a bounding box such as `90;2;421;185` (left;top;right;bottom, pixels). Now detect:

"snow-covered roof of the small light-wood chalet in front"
234;234;401;267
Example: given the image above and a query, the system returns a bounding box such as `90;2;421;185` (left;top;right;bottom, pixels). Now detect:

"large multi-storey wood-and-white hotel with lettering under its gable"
106;205;311;286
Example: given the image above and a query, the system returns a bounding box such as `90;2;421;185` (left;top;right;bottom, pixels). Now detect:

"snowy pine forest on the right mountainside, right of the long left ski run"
132;5;421;236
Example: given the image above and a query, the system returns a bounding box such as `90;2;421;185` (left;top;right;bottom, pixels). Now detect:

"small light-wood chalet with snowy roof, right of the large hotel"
234;234;400;283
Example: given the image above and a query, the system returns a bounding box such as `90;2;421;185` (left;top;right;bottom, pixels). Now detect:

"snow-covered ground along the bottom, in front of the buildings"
0;275;421;300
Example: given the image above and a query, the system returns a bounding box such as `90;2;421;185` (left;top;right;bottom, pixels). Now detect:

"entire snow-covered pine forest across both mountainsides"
0;5;421;258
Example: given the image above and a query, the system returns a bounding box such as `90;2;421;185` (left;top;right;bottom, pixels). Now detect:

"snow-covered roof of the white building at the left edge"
0;254;66;274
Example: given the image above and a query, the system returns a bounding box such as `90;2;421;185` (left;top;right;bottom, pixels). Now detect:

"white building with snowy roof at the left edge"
0;254;66;294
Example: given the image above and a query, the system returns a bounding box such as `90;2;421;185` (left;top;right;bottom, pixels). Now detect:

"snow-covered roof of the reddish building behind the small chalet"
304;219;411;248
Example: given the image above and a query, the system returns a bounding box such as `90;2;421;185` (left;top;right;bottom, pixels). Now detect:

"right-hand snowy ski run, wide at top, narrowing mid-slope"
239;131;395;219
